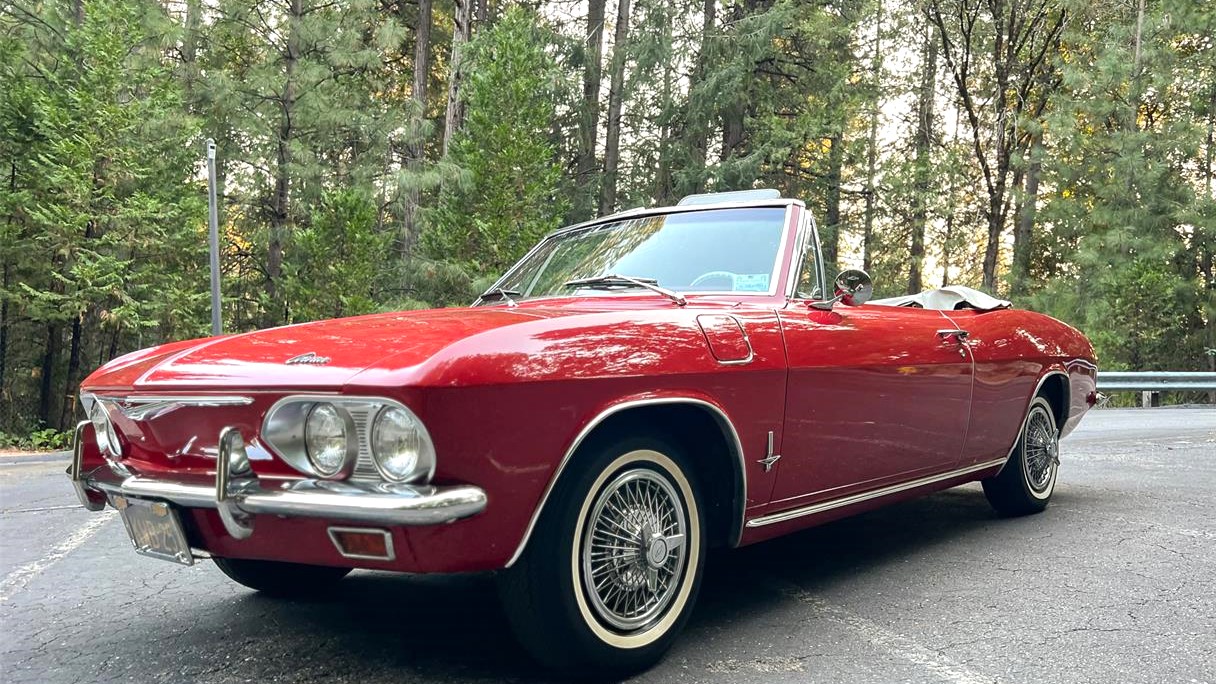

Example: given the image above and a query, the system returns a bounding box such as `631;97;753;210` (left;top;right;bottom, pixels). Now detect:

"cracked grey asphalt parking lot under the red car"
0;408;1216;684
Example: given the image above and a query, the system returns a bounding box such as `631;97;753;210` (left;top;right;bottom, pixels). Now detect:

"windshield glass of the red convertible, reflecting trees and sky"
495;207;786;298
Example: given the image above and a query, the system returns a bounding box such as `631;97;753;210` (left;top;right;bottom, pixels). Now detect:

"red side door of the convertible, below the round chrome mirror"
772;299;973;504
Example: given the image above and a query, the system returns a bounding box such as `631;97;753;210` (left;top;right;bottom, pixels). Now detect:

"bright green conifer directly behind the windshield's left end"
422;7;567;274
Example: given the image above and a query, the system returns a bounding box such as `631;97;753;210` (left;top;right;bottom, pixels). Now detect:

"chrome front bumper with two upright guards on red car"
68;421;485;539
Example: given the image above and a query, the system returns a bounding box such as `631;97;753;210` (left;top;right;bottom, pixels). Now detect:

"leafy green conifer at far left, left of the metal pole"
0;0;206;426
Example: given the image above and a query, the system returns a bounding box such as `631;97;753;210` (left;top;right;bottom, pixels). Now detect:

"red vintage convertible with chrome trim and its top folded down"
69;191;1097;673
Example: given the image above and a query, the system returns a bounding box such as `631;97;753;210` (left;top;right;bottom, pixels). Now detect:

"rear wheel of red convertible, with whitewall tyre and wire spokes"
983;397;1060;515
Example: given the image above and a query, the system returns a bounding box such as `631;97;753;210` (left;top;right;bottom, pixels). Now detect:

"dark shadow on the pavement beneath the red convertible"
169;487;1074;683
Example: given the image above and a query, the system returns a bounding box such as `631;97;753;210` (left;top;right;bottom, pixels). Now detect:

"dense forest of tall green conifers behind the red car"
0;0;1216;445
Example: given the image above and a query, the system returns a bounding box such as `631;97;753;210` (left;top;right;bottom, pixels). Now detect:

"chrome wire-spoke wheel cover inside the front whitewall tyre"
579;467;688;633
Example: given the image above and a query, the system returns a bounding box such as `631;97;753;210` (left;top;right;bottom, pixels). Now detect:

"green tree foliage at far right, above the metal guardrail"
1034;4;1216;370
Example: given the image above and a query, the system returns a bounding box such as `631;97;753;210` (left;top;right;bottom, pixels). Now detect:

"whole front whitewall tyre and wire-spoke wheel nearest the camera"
500;438;705;677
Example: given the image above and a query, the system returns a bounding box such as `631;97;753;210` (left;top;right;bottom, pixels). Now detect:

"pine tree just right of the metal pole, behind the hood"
209;0;403;327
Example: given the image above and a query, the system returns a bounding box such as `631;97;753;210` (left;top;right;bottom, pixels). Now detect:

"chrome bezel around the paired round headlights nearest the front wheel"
261;394;435;484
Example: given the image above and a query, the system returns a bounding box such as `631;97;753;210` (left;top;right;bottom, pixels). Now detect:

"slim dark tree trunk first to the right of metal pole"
263;0;304;325
